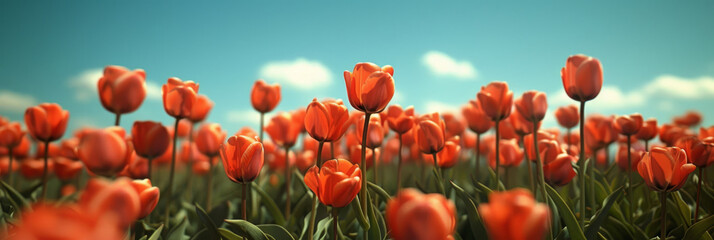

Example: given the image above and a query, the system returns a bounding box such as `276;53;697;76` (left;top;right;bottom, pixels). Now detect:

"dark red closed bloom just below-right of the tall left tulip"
131;121;171;159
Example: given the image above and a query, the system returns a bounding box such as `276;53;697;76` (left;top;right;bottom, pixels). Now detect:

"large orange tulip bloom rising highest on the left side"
97;66;146;114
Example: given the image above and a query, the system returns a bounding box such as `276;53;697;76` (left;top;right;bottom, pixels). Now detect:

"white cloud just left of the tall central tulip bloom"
259;58;332;90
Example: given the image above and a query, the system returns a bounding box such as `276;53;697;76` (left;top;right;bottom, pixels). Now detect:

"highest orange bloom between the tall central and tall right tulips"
476;82;513;121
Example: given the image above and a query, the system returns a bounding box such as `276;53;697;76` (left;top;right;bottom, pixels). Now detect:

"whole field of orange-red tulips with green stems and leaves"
0;57;714;240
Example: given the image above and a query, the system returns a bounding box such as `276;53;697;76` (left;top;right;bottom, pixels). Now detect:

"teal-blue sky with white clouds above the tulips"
0;0;714;132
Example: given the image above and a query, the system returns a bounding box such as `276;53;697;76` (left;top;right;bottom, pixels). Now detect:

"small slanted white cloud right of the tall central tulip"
422;51;478;79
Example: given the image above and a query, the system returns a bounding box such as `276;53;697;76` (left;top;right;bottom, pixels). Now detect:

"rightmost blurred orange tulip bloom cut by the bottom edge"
478;189;550;240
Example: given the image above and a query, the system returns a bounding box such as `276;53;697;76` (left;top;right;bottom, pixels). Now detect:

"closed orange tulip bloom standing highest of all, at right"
560;54;602;102
